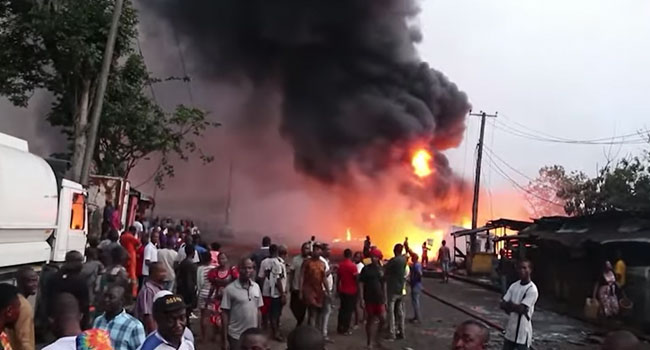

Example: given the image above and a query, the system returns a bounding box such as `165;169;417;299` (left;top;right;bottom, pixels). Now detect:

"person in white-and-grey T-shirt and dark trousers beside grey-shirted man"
260;244;287;342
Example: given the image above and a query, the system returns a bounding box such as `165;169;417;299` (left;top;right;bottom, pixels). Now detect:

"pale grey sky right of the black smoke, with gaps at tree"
0;0;650;224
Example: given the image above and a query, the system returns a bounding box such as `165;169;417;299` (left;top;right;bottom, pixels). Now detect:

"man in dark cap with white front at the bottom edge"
140;294;195;350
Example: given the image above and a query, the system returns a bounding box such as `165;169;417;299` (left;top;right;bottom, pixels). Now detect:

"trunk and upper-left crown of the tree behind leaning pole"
0;0;137;180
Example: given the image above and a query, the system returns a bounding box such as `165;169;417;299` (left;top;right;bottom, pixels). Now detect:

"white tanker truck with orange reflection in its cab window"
0;133;88;275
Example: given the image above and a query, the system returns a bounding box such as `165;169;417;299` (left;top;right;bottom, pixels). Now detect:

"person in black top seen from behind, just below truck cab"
45;247;90;329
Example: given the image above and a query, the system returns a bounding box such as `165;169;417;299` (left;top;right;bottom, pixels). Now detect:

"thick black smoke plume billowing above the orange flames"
145;0;469;183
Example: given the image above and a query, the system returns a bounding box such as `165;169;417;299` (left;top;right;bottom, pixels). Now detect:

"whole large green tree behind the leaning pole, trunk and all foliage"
0;0;213;186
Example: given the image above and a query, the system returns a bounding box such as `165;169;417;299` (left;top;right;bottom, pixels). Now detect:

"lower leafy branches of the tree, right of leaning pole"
48;54;218;187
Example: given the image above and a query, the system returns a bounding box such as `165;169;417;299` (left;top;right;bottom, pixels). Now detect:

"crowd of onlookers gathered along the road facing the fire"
0;222;644;350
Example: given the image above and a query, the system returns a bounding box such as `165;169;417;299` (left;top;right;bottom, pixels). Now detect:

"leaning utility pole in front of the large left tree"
81;0;124;186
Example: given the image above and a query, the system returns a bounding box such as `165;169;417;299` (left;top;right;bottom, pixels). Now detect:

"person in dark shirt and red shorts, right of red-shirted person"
359;248;386;348
